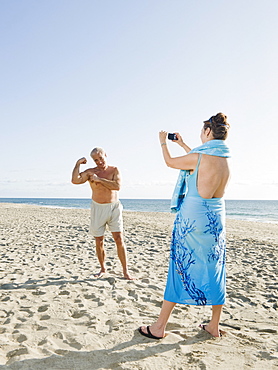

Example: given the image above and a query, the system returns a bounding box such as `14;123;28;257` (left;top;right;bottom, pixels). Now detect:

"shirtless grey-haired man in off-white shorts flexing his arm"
71;148;132;280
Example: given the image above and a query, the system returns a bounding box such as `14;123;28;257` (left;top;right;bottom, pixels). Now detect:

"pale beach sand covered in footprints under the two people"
0;204;278;370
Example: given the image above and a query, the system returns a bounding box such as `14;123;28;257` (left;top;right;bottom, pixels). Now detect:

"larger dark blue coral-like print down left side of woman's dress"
170;213;207;306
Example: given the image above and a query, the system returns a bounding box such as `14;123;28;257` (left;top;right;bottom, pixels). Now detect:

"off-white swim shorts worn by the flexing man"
89;200;123;237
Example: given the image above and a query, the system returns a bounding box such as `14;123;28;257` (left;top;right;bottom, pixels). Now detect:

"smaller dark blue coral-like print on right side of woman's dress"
203;201;226;265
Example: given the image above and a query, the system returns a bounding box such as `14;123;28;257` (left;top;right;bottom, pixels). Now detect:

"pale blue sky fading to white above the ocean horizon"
0;0;278;200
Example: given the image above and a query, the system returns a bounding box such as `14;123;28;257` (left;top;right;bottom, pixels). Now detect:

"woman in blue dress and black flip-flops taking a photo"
139;113;230;339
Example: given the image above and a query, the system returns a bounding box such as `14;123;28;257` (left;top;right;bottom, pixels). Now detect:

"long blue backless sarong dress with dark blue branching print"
164;140;229;305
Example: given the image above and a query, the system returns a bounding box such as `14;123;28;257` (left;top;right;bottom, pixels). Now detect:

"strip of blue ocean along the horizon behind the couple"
0;198;278;223
